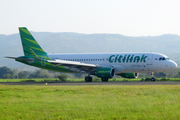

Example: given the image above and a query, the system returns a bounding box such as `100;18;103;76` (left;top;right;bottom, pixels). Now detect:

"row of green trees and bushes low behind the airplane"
0;66;180;79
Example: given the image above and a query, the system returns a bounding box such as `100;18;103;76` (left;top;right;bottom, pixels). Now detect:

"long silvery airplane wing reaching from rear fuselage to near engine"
47;60;99;72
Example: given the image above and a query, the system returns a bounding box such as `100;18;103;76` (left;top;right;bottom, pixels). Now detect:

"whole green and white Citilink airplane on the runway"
6;27;177;82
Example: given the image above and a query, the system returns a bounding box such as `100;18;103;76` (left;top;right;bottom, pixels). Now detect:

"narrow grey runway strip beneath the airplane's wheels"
0;81;180;86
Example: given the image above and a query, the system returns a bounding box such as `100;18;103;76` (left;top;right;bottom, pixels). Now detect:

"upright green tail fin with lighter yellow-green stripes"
19;27;47;56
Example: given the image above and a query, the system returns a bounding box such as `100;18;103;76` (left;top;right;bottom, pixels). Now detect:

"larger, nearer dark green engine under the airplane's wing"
96;68;115;78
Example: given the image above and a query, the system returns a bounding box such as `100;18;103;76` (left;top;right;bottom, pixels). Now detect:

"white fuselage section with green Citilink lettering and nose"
48;53;177;74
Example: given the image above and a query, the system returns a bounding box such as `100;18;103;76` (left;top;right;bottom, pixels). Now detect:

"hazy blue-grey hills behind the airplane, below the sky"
0;32;180;69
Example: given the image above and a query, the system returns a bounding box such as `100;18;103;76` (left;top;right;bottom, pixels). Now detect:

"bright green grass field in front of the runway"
0;85;180;120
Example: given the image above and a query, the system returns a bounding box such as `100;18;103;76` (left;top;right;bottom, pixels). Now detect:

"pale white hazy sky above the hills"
0;0;180;36
